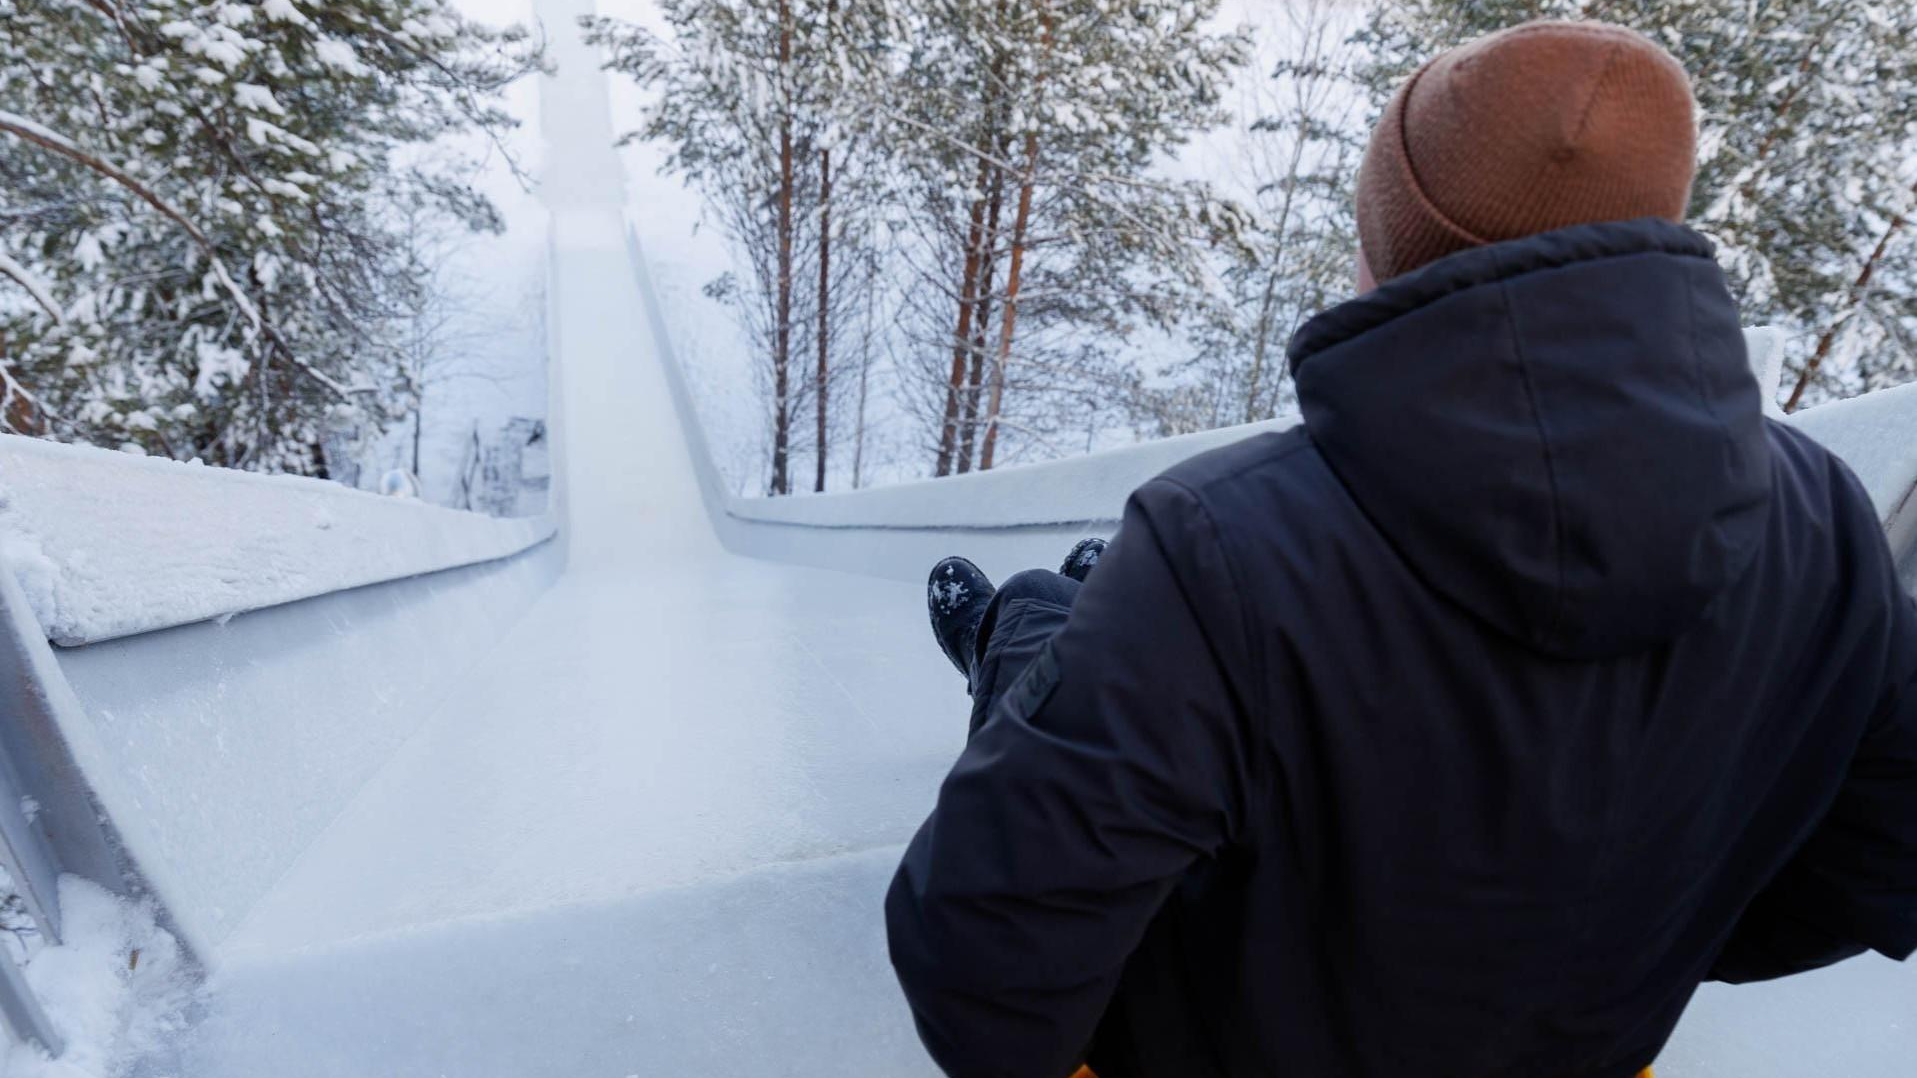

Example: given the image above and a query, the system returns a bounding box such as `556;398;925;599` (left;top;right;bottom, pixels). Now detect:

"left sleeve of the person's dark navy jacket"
886;480;1256;1078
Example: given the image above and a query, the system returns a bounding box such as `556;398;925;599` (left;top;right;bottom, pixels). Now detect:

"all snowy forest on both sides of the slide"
0;0;1917;493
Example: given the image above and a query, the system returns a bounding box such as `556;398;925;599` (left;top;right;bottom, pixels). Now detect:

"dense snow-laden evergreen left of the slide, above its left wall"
0;0;539;474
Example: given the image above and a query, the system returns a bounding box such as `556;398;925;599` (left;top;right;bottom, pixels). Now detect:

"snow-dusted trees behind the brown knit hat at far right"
1363;0;1917;409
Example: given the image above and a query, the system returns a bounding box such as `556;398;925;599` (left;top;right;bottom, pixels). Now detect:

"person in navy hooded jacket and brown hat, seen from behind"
886;23;1917;1078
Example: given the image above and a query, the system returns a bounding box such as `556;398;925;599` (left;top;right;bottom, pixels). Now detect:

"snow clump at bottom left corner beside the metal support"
0;877;194;1078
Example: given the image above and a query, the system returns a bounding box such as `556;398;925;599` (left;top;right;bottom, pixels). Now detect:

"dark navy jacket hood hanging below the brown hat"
1290;219;1771;658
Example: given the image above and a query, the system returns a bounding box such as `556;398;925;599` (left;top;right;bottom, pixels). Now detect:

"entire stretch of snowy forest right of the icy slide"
587;0;1917;495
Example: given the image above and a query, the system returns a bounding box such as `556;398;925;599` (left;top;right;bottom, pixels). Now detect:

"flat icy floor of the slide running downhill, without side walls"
119;12;966;1078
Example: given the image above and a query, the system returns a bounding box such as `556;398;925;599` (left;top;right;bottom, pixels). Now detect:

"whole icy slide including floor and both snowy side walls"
0;2;1917;1078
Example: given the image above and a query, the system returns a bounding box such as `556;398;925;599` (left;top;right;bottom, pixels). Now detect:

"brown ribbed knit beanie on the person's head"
1357;21;1697;282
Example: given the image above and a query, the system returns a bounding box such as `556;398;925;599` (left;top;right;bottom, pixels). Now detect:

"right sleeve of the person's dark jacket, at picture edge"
1710;480;1917;984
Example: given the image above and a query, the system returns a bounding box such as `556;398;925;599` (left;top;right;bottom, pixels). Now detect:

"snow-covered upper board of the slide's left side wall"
0;435;552;644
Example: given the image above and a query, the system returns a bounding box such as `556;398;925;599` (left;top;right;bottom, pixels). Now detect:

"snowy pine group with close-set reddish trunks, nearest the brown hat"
872;0;1246;474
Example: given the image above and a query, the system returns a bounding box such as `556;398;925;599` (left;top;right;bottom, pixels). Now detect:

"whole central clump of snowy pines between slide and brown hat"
587;0;1244;479
